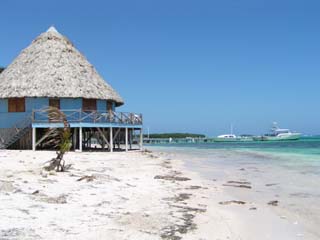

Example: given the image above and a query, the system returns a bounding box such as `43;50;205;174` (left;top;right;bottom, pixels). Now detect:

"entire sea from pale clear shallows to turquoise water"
147;137;320;239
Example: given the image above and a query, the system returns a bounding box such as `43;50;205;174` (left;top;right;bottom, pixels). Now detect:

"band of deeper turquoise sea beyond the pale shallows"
150;136;320;172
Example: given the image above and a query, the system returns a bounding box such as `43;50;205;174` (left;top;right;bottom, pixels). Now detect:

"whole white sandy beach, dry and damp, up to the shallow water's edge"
0;151;308;240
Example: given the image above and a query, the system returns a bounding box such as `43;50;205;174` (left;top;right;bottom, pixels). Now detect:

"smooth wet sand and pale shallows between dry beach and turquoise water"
150;147;320;240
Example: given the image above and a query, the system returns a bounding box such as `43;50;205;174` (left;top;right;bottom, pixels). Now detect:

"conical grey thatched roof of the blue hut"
0;27;123;105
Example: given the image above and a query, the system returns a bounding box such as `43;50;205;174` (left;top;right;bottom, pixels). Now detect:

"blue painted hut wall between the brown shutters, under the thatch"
0;98;115;128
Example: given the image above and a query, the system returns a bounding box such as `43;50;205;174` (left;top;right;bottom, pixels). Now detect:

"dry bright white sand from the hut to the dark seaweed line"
0;151;210;239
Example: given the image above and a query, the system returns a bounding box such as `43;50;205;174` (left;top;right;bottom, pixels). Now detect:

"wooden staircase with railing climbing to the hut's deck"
0;116;32;149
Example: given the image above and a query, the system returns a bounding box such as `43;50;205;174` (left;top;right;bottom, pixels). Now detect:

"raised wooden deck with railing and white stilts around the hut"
0;109;143;152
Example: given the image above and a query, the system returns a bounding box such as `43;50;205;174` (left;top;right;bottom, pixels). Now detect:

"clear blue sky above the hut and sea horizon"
0;0;320;136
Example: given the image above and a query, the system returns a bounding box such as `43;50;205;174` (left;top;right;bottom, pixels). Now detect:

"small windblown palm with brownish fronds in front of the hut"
44;107;72;172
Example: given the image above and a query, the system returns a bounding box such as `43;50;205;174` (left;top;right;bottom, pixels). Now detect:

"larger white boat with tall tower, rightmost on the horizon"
254;122;301;141
